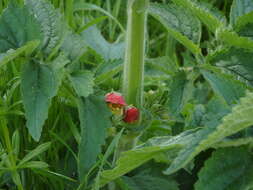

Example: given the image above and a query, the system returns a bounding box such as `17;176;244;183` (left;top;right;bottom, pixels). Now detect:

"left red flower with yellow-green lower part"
105;92;126;115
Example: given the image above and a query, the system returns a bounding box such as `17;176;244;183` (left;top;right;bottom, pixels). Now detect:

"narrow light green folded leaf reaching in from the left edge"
0;41;40;67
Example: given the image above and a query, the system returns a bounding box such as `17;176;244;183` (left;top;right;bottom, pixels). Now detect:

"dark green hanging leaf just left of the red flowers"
78;95;111;180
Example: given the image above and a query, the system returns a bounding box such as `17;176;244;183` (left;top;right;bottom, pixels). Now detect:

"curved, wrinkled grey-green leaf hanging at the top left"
26;0;66;54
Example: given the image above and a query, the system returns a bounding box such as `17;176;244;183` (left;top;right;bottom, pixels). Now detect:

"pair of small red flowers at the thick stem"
105;92;140;123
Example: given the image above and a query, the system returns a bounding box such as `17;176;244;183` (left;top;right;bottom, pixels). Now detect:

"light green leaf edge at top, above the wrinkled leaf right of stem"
173;0;226;32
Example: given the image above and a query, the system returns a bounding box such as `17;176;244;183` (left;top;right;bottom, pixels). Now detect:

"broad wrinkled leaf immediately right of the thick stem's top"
148;3;201;54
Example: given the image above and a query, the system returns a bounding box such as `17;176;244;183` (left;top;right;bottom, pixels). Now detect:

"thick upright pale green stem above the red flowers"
123;0;149;108
